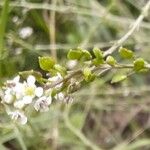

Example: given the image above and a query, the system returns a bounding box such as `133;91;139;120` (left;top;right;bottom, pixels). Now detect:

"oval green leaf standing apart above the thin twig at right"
119;47;134;59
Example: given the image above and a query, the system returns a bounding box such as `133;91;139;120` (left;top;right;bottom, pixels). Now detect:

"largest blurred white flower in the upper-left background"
19;27;33;39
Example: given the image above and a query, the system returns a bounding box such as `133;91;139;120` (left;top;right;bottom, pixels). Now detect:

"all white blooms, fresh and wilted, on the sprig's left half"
1;73;72;124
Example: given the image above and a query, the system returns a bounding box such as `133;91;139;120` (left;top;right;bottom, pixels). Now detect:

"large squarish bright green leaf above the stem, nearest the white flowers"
39;57;55;71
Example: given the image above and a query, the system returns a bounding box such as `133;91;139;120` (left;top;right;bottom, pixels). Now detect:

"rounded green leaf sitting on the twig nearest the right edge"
133;58;146;72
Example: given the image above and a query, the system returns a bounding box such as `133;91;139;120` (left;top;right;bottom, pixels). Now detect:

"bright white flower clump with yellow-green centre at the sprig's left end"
2;75;43;106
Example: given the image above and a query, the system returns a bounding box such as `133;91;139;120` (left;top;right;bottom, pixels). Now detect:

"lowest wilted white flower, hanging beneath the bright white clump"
8;110;27;124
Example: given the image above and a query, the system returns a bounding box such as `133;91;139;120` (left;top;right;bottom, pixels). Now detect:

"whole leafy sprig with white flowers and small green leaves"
0;47;150;124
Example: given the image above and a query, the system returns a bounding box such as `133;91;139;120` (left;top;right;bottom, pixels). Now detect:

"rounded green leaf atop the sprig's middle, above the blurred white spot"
67;49;82;60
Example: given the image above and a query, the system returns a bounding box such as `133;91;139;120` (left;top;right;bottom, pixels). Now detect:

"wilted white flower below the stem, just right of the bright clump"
34;96;52;112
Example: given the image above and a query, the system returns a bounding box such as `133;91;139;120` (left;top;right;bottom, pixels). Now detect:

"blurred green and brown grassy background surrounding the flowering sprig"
0;0;150;150
